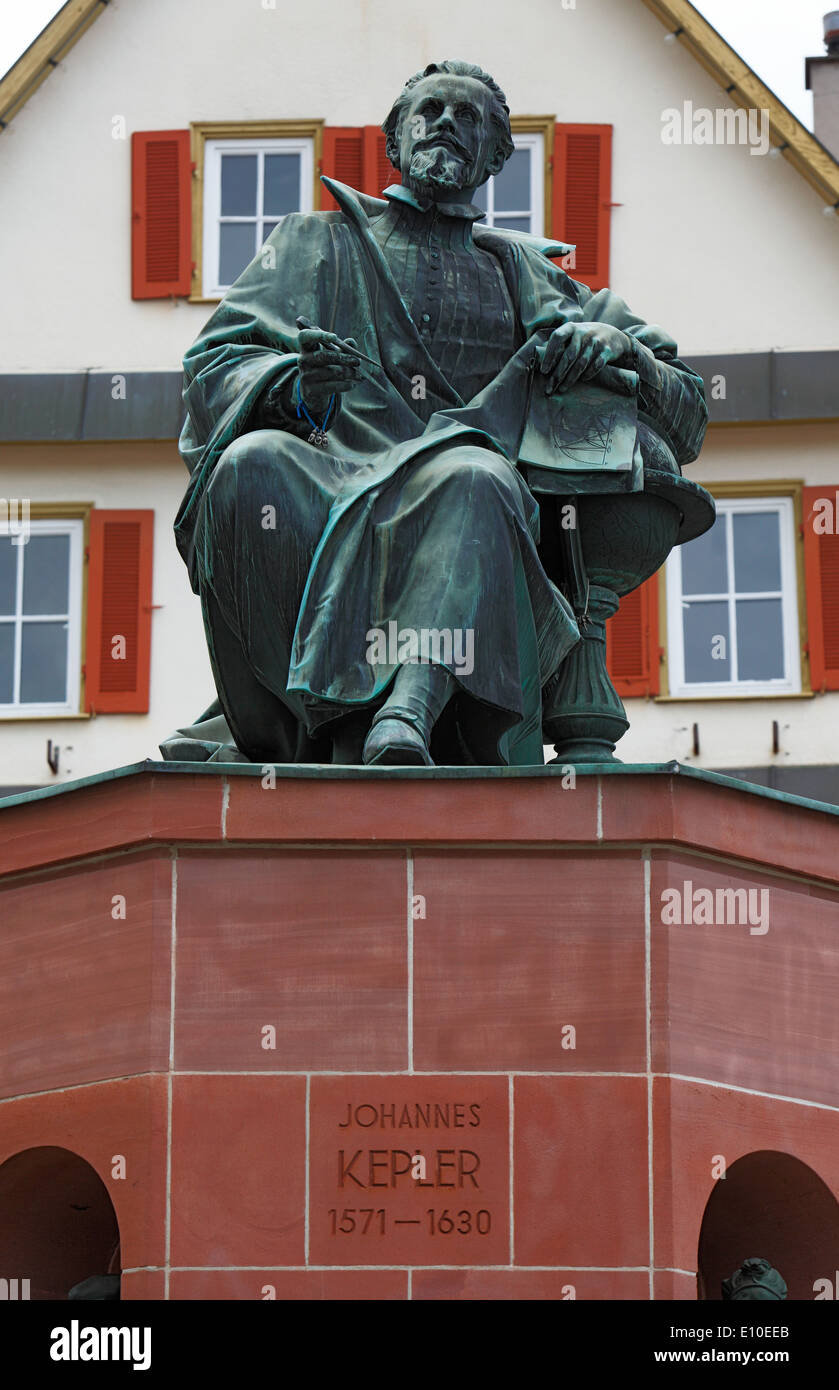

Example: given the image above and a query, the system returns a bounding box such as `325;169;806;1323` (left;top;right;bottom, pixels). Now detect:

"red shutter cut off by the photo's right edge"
803;487;839;691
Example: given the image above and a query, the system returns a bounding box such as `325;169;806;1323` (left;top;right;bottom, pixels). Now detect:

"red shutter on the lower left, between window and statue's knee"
85;509;154;714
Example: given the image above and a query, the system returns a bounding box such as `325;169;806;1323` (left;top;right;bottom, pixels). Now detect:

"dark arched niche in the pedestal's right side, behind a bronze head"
697;1150;839;1301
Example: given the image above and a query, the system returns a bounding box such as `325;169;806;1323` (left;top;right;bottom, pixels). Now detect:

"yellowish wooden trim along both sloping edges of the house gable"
0;0;839;213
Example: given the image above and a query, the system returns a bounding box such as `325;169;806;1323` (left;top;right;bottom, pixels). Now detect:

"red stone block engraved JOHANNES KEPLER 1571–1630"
311;1077;510;1265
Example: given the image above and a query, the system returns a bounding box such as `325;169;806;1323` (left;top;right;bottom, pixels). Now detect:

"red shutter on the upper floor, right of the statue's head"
553;125;611;289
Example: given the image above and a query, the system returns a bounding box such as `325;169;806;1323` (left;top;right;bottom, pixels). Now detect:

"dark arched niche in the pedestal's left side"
0;1145;119;1300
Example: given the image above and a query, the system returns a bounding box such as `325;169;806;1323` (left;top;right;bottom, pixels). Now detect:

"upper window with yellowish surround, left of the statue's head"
190;121;324;300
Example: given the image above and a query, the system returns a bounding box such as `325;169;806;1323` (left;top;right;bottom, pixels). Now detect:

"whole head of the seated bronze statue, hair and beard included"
382;60;513;197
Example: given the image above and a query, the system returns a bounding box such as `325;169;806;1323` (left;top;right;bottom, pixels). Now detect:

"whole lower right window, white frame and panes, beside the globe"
667;496;801;696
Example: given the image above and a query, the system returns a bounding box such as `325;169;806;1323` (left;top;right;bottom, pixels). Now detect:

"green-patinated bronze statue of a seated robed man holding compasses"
161;61;713;766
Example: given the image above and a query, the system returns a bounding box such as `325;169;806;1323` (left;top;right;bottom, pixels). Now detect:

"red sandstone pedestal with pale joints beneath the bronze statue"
0;763;839;1300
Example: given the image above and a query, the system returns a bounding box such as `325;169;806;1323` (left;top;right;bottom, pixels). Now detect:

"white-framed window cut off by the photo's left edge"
0;518;85;719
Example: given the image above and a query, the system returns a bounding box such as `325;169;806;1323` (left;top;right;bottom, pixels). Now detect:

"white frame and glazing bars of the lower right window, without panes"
665;496;801;699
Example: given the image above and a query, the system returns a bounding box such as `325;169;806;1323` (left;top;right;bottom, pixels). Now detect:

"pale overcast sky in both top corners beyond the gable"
0;0;839;129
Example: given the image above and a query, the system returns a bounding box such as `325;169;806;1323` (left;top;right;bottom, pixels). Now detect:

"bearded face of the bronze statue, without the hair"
397;72;504;197
